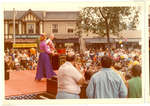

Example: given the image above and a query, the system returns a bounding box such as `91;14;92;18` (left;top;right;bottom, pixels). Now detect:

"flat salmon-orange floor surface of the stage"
5;70;46;97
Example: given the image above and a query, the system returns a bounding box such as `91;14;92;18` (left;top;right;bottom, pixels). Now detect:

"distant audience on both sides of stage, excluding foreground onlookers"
5;48;141;72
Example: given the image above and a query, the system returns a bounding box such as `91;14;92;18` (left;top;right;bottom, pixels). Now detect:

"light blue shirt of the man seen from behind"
86;68;127;98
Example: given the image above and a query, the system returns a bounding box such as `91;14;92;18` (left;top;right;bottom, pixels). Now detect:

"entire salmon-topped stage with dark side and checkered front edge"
5;70;87;100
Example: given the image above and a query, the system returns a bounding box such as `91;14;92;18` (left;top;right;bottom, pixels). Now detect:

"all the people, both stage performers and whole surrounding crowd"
5;35;142;99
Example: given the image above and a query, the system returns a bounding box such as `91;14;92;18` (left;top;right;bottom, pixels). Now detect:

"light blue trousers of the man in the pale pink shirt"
56;91;80;99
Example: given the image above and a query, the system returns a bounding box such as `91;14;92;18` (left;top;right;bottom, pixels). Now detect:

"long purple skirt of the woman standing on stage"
35;52;56;80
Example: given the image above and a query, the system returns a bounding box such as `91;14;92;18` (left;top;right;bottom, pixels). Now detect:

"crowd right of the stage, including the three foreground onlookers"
56;48;142;99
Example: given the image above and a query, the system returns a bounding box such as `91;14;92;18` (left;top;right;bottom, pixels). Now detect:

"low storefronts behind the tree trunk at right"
84;38;141;49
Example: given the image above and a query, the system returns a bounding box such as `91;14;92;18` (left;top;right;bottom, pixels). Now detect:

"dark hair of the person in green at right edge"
131;65;141;77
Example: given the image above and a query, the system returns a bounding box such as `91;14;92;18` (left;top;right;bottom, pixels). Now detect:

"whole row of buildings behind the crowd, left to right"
4;9;141;49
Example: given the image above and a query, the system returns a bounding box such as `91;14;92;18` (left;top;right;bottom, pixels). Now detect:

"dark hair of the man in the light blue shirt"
101;56;112;68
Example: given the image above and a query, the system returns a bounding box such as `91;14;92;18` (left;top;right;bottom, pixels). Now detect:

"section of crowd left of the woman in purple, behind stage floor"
4;49;38;71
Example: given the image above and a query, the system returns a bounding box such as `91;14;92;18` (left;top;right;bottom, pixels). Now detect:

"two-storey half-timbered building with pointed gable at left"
4;9;79;48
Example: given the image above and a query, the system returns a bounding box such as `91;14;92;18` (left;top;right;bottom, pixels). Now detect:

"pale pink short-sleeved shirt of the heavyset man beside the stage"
58;62;82;94
